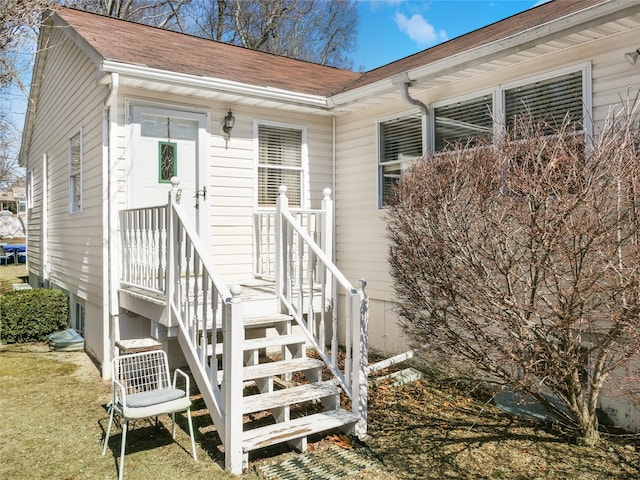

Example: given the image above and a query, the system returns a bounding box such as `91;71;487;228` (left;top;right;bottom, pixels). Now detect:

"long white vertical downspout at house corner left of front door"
102;73;120;378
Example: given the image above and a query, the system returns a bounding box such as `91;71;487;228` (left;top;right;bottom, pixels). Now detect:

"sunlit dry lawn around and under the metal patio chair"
0;344;238;480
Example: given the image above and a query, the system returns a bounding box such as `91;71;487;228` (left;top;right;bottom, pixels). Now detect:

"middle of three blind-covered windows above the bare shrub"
433;95;493;152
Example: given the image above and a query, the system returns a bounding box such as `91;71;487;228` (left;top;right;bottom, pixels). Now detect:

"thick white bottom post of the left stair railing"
222;285;244;475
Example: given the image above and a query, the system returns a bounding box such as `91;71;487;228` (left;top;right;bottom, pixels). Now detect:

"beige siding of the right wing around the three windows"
336;30;640;353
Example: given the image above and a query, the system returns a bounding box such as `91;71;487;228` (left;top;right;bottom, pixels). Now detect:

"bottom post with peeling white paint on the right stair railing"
351;278;369;439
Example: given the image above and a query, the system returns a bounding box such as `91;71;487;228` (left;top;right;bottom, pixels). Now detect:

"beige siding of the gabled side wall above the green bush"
27;29;106;366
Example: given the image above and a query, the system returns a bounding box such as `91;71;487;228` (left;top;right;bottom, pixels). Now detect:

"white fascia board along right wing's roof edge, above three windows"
328;0;640;107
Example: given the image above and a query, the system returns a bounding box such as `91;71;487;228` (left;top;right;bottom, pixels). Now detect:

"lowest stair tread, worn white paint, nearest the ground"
242;409;358;452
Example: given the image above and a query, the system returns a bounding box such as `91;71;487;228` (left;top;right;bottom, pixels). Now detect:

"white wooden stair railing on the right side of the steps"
275;186;369;437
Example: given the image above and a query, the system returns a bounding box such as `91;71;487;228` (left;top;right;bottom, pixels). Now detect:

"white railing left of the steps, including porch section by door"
120;179;244;473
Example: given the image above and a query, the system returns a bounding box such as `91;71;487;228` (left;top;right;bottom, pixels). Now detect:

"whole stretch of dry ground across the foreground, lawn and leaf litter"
0;345;640;480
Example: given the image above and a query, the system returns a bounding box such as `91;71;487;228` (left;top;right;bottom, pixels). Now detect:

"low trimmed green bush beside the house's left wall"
0;288;69;343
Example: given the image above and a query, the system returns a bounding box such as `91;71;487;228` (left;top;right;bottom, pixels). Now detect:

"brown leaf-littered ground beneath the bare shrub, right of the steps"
368;366;640;480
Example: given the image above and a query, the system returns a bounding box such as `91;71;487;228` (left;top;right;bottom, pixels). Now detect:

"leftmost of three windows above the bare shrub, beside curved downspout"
378;113;423;206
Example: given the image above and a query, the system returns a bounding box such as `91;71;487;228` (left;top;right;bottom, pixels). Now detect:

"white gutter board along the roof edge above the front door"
100;60;328;109
